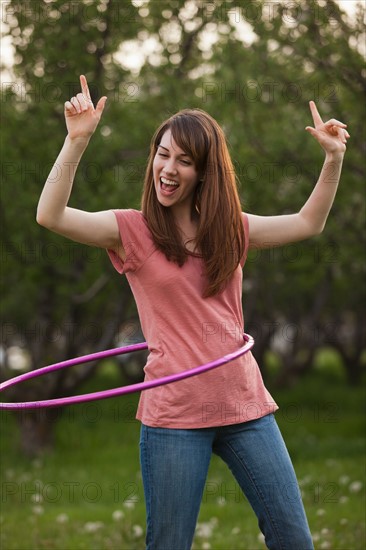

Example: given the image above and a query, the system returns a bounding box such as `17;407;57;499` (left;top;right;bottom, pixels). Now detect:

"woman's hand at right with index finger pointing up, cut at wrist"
305;101;351;154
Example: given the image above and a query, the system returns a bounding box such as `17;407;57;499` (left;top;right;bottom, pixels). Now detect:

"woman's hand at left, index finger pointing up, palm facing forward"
65;75;107;139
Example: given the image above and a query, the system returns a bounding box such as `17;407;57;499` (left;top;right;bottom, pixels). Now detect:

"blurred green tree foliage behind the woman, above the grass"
1;0;366;448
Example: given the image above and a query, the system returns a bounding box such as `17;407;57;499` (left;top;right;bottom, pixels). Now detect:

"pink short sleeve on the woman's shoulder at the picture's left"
107;209;154;274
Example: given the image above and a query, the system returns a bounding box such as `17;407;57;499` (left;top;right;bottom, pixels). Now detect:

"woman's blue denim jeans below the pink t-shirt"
140;414;314;550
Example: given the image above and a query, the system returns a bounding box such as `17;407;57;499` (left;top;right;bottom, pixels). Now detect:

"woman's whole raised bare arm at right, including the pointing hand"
248;101;350;248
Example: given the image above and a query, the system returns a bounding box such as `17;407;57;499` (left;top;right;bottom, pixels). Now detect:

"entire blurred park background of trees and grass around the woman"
0;0;366;550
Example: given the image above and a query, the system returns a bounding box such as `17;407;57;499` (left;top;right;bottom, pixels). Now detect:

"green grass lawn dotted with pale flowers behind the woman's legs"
0;364;366;550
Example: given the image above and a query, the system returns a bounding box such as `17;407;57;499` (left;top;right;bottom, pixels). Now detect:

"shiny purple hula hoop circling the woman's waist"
0;334;254;409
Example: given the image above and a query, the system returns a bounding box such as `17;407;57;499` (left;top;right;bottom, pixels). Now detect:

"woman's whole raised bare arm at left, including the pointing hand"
37;75;123;255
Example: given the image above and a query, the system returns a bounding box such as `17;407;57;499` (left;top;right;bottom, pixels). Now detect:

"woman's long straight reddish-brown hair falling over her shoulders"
142;109;245;297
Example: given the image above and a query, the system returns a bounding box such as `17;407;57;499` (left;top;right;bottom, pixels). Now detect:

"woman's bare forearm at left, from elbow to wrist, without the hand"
37;136;89;227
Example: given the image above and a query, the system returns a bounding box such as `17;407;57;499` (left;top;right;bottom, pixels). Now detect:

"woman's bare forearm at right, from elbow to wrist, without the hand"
299;153;344;236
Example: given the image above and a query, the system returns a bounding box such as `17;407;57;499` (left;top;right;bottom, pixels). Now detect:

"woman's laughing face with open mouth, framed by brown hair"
153;130;198;213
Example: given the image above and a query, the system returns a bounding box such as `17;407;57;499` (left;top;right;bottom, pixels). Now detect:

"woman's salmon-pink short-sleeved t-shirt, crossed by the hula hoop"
108;210;278;428
